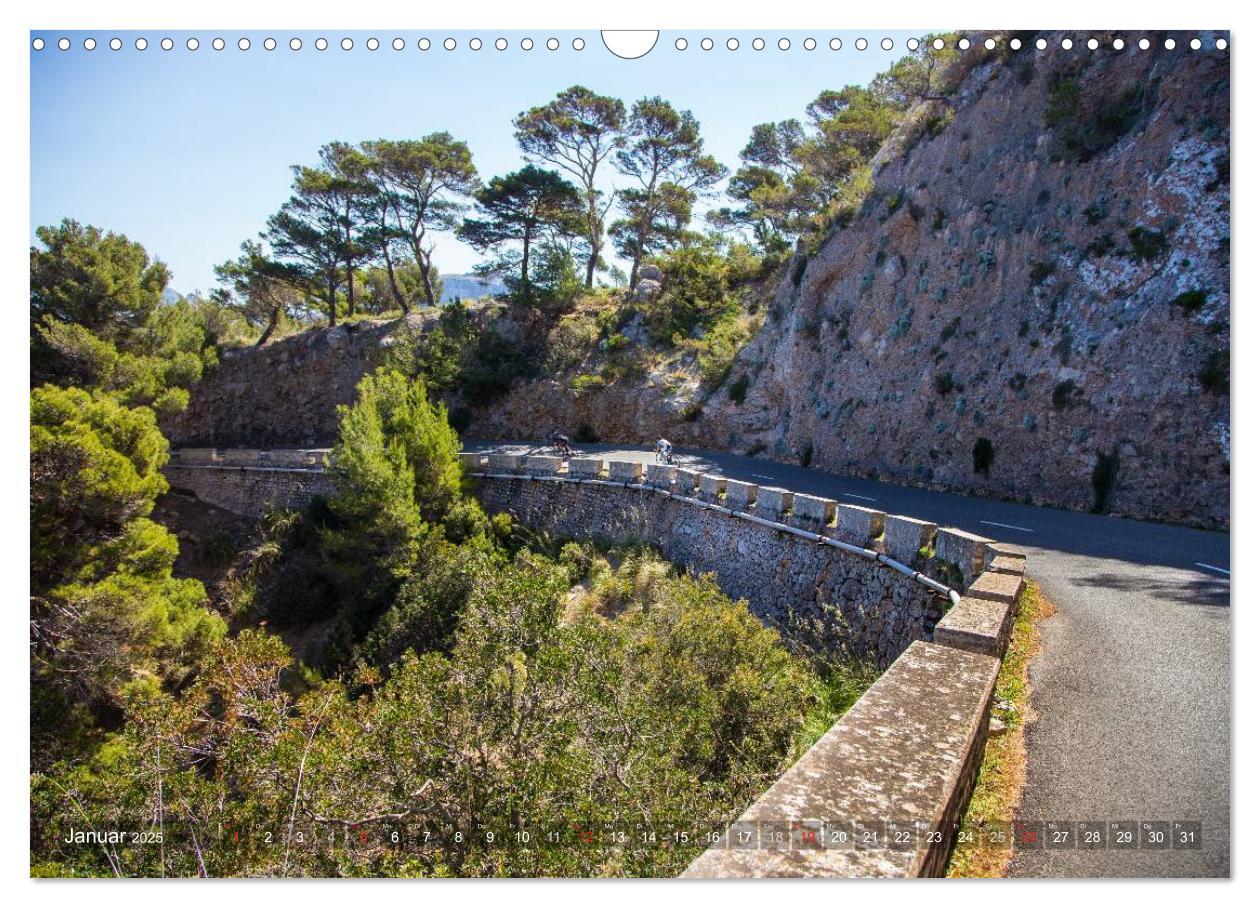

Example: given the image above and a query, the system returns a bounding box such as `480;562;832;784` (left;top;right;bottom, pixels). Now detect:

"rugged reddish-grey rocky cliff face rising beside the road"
169;35;1230;528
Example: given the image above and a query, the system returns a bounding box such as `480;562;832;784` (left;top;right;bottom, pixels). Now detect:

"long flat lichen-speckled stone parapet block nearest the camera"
683;641;999;878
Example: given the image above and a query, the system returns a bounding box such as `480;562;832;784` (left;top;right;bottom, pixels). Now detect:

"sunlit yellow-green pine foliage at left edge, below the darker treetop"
30;385;224;761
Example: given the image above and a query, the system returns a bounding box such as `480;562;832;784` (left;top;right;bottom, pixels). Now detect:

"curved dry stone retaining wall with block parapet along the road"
166;448;1024;877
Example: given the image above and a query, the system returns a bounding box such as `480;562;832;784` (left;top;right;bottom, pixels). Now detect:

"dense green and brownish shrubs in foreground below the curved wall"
32;547;826;877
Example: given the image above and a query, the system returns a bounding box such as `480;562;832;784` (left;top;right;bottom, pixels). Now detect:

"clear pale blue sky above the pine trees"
30;31;911;293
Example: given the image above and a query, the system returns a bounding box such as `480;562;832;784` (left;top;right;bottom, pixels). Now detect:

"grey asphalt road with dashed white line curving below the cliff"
469;443;1231;877
